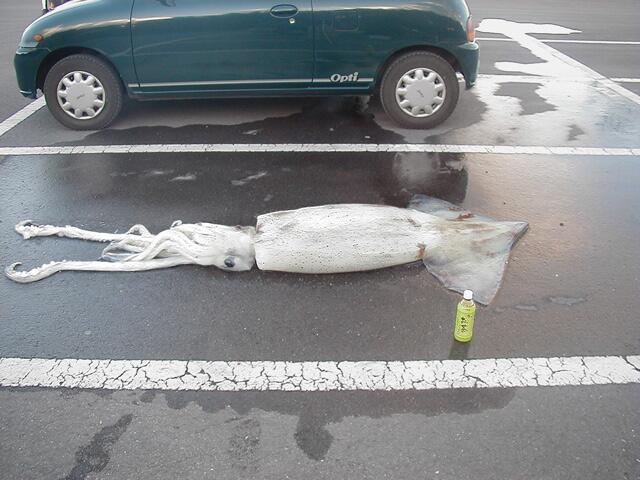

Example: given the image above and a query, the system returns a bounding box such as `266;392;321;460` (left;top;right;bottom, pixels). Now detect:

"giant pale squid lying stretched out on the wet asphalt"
5;195;528;304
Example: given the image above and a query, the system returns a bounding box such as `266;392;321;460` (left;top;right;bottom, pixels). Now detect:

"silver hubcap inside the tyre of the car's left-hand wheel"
57;72;105;120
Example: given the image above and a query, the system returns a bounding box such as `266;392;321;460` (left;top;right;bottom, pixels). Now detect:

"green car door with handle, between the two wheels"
131;0;313;93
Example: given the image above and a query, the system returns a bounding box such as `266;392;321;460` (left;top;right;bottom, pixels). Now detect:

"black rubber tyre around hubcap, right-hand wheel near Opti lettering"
380;52;460;129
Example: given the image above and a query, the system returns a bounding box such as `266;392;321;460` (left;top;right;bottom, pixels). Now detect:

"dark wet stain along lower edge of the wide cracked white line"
135;388;515;461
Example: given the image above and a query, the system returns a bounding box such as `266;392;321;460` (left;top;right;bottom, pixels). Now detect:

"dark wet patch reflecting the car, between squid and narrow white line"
28;153;469;221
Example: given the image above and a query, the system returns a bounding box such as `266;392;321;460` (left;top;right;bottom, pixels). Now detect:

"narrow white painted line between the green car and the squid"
0;143;640;156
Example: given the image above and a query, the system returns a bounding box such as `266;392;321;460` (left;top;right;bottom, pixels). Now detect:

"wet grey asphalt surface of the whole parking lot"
0;0;640;480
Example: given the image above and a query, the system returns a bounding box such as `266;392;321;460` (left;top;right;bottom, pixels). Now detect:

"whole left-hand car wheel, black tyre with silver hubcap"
44;54;124;130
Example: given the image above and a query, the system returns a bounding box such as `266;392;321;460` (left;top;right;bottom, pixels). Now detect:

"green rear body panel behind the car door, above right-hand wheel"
313;0;473;89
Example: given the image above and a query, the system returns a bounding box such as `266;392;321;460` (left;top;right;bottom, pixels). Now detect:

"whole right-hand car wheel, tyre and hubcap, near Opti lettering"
380;52;460;129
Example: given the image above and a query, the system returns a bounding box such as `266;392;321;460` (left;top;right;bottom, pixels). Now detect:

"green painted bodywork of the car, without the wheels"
15;0;478;98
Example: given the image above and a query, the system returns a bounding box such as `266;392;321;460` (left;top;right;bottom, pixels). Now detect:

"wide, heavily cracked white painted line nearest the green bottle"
0;355;640;392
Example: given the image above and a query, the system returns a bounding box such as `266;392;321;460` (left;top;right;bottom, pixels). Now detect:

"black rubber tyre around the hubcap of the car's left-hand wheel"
43;54;124;130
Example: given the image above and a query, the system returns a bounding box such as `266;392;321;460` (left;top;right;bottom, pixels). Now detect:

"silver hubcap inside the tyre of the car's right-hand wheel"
396;68;447;118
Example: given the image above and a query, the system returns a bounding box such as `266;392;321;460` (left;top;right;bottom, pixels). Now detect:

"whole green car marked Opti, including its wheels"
15;0;478;130
